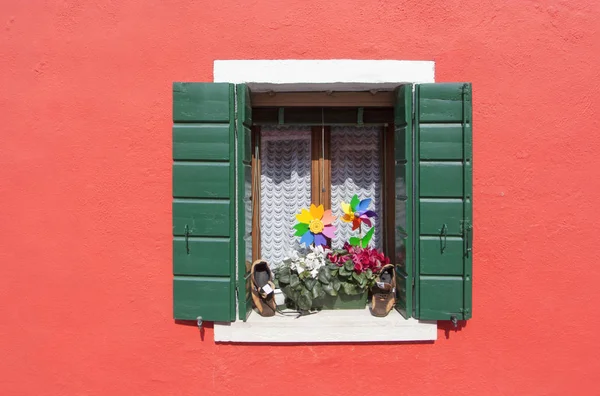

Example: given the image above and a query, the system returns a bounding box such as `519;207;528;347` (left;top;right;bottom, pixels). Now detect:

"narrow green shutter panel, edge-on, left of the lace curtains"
236;84;254;321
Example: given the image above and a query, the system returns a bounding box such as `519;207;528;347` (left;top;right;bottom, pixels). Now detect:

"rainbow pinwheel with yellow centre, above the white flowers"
294;204;335;247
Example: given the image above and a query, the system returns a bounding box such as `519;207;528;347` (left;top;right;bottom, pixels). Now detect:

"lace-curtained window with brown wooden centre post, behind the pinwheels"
253;124;386;266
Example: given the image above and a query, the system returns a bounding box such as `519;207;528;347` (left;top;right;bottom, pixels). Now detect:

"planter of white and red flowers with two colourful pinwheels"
274;195;390;311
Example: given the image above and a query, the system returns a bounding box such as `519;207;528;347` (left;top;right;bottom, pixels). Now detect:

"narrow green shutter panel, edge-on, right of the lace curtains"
393;85;413;319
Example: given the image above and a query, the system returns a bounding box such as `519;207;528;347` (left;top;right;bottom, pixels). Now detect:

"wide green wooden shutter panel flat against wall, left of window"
173;83;235;321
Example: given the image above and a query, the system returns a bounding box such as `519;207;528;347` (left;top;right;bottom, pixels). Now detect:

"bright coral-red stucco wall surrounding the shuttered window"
0;0;600;396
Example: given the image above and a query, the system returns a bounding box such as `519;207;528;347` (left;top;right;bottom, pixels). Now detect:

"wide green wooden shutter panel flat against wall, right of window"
415;83;473;320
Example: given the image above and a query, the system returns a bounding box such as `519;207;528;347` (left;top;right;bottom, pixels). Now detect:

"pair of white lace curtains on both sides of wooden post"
260;126;383;268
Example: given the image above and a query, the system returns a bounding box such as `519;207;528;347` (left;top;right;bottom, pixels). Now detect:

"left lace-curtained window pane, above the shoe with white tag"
260;126;311;268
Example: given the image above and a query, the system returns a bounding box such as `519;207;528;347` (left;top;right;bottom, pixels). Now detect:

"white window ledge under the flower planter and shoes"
214;308;437;343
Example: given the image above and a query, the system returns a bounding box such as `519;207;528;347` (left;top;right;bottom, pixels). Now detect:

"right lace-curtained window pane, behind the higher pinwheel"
331;126;383;249
